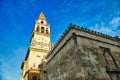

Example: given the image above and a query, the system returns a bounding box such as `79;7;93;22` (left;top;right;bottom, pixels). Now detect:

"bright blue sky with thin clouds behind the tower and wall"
0;0;120;80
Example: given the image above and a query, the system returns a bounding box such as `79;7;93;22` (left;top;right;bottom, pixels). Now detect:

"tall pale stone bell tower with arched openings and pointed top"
21;13;51;80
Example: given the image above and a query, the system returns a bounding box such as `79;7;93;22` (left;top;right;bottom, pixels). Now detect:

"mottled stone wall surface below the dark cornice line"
47;31;120;80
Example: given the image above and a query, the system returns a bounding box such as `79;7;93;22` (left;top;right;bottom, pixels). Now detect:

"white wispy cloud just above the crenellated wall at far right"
90;19;120;36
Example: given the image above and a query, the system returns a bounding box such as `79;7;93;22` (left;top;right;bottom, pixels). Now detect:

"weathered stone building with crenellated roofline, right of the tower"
46;25;120;80
